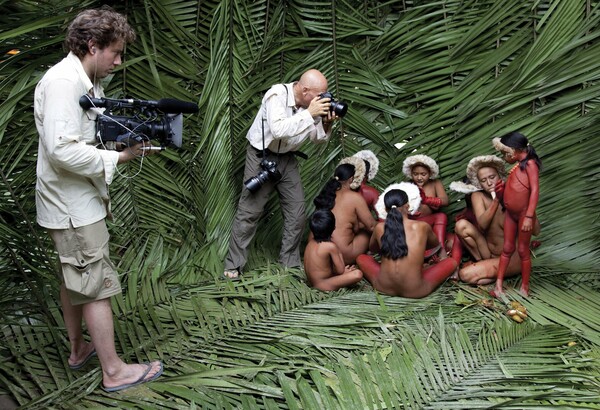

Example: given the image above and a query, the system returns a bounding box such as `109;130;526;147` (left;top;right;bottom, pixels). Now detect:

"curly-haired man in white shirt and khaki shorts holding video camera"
34;8;163;392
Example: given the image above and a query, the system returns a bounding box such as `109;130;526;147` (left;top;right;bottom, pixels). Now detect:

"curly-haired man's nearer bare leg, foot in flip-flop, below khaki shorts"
83;299;161;388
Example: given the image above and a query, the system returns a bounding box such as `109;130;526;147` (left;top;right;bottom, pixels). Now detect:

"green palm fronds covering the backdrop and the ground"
0;0;600;409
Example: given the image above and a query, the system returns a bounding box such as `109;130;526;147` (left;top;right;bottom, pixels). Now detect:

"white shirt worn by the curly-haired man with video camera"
33;53;119;229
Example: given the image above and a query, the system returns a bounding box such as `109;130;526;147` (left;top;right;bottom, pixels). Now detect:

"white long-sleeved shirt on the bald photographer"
246;83;331;153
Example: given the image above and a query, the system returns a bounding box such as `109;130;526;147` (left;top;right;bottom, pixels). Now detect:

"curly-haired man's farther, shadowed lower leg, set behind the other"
60;283;94;366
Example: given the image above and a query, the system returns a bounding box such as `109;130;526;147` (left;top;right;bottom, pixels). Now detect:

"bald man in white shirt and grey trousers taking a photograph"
223;69;336;279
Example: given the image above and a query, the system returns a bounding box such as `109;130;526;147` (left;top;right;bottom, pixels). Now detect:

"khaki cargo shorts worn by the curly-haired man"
48;220;121;305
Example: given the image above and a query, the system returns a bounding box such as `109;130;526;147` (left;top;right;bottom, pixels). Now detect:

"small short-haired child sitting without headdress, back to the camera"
304;209;362;291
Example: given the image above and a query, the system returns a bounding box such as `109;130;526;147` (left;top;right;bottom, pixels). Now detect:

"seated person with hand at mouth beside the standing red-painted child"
450;155;540;285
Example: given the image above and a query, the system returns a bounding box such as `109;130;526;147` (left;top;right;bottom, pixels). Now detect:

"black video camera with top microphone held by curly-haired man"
79;94;198;150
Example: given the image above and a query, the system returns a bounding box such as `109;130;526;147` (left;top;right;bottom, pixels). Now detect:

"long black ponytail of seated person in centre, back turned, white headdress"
381;189;408;260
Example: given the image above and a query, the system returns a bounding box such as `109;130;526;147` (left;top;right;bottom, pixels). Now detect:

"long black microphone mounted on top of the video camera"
79;94;198;114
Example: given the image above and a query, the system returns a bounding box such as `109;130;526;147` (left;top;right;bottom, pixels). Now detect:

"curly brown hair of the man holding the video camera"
65;6;135;58
